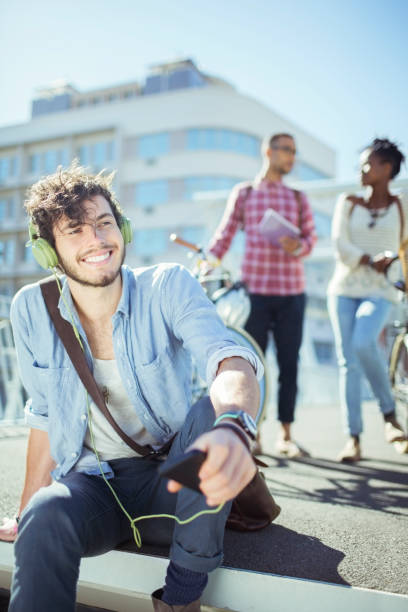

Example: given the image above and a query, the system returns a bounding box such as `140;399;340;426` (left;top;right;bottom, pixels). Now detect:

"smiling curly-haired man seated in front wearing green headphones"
0;164;262;612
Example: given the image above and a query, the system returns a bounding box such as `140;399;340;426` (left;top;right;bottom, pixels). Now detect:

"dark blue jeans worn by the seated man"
9;397;231;612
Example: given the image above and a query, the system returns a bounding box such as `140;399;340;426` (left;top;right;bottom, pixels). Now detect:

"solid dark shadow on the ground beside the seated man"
223;525;349;585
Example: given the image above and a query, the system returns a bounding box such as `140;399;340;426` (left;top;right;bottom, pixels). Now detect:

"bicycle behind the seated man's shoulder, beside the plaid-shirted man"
170;234;269;425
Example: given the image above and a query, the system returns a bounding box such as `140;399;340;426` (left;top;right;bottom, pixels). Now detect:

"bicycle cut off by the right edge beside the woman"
385;254;408;453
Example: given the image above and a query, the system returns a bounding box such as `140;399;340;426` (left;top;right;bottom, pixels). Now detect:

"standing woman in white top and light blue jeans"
328;138;408;462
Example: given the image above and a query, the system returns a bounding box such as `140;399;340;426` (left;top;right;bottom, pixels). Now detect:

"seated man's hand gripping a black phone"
167;428;256;506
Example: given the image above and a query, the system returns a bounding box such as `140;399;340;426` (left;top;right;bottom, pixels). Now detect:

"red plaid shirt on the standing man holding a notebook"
209;180;317;295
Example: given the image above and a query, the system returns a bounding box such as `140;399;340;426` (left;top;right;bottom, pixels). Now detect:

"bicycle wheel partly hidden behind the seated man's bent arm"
192;325;269;425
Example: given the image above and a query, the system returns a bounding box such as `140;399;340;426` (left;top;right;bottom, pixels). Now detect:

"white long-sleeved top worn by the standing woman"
327;194;408;302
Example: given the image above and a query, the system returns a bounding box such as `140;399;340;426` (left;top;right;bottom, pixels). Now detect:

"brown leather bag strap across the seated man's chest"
40;277;167;456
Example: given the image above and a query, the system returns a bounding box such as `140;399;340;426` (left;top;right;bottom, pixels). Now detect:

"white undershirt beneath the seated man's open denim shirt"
84;359;157;461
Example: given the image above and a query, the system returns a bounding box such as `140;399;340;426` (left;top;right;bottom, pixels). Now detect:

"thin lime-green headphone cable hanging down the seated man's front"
52;268;224;548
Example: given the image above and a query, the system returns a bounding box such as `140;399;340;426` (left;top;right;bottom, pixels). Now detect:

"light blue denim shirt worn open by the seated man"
11;264;263;480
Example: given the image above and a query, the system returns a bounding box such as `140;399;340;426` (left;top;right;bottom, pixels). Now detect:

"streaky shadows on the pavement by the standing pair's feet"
262;454;408;516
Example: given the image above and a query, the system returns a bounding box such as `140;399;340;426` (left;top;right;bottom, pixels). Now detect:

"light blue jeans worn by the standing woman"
328;295;395;435
